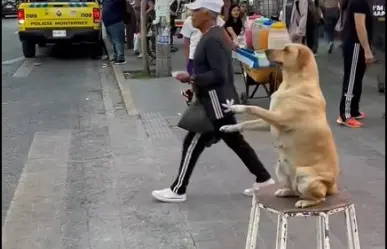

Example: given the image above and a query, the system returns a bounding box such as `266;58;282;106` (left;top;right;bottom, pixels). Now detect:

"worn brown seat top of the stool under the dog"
254;184;352;216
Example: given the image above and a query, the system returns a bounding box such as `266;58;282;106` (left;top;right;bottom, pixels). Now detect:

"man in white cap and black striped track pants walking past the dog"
152;0;274;202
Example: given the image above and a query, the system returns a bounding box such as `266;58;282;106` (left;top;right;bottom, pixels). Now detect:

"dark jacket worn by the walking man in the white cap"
194;26;239;120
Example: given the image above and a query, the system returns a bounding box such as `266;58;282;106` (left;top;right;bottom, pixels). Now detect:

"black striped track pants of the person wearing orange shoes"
340;42;365;122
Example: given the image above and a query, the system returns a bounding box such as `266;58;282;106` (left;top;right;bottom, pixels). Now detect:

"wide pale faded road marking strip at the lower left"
2;130;71;249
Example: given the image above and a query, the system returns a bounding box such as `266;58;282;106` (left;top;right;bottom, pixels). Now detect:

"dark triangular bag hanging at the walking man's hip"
177;97;214;133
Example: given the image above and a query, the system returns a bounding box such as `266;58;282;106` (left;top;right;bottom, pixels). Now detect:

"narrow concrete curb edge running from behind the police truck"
103;37;139;116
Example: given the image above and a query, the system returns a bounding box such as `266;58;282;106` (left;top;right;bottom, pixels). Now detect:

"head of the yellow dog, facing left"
266;43;317;72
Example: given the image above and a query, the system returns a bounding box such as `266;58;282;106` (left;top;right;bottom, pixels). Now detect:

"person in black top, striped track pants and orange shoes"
337;0;374;128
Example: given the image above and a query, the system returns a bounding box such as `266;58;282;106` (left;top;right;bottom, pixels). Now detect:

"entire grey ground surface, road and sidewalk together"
2;16;385;249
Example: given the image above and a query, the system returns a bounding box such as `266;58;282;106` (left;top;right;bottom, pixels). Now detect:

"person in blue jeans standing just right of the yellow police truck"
102;0;129;64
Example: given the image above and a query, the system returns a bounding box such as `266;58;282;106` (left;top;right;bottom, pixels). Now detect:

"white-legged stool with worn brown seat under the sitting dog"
246;184;360;249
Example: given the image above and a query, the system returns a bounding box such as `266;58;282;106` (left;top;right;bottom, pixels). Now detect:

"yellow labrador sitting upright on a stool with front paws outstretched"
220;43;339;208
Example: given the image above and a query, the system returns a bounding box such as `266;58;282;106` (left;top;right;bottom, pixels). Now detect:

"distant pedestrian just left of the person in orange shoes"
324;0;340;54
